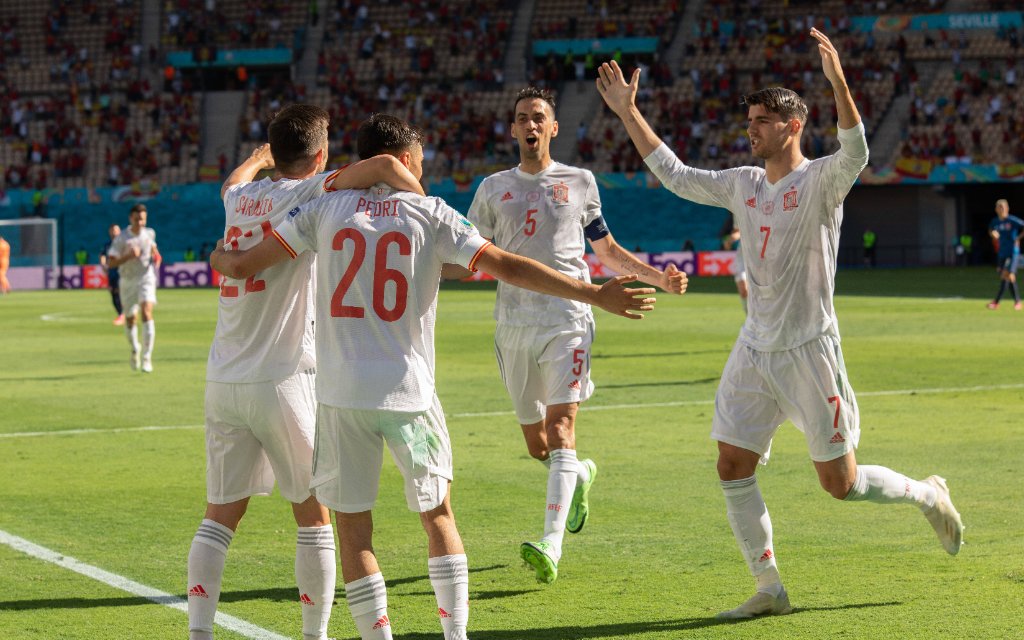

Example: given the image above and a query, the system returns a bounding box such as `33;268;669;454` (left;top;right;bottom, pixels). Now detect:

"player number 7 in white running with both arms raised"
597;29;964;618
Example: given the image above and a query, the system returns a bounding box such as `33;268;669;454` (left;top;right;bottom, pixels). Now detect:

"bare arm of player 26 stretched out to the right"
476;245;655;319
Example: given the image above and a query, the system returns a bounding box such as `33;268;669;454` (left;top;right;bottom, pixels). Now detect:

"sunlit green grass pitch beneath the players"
0;268;1024;640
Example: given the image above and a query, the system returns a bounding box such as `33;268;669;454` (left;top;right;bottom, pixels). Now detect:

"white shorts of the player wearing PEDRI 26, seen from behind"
310;395;452;513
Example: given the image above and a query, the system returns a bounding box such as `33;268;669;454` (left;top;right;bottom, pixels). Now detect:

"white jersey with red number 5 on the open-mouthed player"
469;162;601;326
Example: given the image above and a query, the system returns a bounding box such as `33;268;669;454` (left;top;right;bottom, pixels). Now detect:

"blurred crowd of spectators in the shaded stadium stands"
0;0;1024;189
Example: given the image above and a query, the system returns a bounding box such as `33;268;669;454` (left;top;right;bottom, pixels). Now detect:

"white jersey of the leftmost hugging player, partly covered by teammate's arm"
206;170;340;382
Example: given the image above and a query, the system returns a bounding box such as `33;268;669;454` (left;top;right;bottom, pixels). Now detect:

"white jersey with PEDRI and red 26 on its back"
274;184;490;412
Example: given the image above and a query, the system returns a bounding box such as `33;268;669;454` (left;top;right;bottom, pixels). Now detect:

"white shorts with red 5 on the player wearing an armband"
495;314;594;424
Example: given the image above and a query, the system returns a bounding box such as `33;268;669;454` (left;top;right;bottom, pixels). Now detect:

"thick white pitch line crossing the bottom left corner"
0;530;289;640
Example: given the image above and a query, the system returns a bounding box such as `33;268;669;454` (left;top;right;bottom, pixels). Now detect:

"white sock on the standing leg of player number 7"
721;475;782;596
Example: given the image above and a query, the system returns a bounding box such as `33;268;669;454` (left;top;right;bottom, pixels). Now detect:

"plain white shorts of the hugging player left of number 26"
206;371;316;505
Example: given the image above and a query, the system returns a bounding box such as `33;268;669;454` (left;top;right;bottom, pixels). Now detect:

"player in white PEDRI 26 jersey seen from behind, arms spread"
211;114;654;640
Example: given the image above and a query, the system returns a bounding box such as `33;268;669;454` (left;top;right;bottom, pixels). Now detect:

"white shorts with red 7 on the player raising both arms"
711;336;860;464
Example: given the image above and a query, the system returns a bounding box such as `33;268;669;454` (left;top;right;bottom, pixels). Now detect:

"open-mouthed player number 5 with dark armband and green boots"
469;87;686;584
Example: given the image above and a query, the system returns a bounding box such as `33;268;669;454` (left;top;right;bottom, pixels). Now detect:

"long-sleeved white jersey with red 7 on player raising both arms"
645;119;867;351
